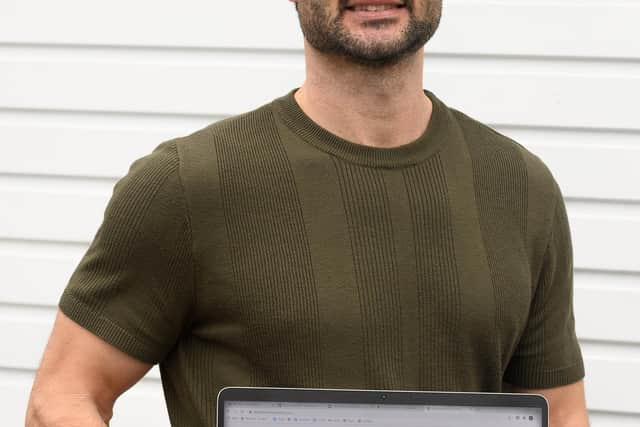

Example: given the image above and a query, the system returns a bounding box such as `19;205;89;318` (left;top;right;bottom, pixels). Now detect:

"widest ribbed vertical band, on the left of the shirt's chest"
216;110;322;386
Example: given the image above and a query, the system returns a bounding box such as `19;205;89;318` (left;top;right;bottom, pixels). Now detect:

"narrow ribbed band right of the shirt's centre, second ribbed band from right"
403;155;461;390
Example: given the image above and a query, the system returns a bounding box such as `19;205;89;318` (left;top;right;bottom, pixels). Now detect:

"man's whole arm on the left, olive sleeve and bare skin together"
30;141;195;425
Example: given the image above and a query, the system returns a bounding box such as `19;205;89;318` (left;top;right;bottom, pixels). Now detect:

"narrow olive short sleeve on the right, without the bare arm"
504;185;584;388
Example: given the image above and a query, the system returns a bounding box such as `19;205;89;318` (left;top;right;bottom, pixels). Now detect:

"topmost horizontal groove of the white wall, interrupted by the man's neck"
0;41;640;64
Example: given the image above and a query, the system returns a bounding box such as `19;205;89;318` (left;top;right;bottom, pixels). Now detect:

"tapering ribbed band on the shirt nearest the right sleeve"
467;127;536;370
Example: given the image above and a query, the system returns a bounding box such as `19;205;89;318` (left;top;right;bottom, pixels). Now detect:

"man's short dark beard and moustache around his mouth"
298;0;440;68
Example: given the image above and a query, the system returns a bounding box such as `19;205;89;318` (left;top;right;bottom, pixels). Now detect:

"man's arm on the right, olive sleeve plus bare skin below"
503;183;588;427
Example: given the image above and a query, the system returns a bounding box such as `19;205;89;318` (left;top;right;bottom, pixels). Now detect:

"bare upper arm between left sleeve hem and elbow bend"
33;311;152;420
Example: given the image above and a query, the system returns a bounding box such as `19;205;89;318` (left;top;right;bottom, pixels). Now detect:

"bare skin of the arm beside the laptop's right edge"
504;380;589;427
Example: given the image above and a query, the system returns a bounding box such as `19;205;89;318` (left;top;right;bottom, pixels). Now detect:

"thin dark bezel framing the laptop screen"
216;387;549;427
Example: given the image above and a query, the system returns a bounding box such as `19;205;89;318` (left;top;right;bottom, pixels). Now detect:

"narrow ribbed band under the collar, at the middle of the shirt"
334;160;403;388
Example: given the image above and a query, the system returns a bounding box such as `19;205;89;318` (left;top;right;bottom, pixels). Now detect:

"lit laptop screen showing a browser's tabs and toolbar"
224;401;543;427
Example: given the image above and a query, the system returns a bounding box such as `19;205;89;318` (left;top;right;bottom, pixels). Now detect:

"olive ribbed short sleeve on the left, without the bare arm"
59;141;194;363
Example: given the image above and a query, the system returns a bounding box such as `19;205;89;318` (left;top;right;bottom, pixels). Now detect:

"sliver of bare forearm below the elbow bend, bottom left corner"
25;391;112;427
